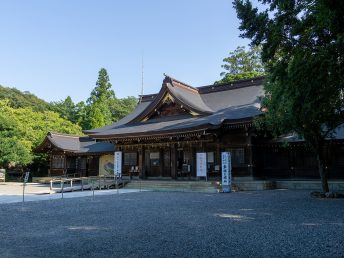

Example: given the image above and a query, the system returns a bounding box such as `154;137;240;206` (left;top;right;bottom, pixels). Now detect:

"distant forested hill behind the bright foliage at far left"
0;85;52;111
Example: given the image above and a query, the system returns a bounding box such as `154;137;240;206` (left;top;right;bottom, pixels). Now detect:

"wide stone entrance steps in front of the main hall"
124;180;218;193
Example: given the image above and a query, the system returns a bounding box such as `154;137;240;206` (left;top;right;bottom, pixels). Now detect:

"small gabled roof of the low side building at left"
36;132;114;154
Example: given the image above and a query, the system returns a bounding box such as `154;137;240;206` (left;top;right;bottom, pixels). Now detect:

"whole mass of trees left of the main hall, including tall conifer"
0;68;137;171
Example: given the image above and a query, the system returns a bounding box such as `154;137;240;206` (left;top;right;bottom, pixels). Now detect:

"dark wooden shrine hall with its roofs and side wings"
37;75;344;179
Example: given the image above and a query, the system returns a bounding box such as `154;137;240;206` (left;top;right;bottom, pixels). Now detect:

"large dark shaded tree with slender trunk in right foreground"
233;0;344;192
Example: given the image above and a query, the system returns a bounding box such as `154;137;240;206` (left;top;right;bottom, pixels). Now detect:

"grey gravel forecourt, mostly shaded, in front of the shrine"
0;190;344;257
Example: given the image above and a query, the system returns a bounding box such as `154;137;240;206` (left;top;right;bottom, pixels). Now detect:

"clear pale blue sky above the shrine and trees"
0;0;248;102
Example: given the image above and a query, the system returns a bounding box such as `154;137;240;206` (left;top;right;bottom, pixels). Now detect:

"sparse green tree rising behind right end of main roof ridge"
215;46;264;84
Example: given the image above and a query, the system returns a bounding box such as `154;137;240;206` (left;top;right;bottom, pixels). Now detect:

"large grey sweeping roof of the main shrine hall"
85;75;264;139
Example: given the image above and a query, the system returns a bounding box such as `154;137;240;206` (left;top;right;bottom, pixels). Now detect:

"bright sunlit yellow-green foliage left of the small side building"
0;100;81;167
